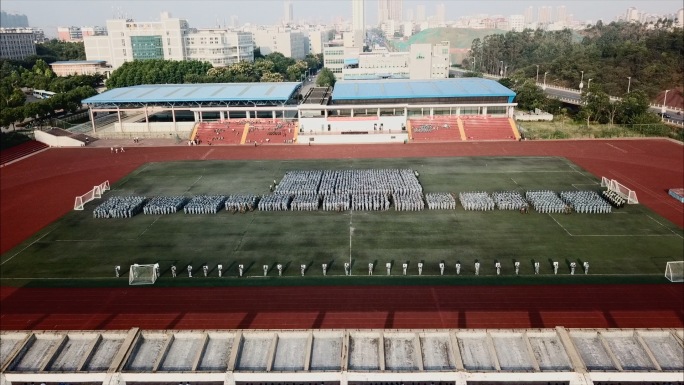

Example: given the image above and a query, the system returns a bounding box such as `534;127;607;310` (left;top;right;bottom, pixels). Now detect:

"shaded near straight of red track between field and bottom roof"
0;284;684;330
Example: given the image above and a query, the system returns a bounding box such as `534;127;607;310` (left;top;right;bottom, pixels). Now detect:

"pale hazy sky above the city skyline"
0;0;682;35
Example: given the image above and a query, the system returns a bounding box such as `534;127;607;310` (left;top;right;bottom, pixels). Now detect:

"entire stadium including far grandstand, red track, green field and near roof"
0;76;684;384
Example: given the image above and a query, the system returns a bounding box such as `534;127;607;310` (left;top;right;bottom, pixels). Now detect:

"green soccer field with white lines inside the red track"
0;157;684;285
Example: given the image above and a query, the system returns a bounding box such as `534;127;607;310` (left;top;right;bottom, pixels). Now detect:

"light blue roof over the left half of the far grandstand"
83;82;301;104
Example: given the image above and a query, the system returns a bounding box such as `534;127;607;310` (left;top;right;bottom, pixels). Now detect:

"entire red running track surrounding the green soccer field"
0;139;684;330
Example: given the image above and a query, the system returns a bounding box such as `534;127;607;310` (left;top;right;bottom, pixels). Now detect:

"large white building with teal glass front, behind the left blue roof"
83;13;254;69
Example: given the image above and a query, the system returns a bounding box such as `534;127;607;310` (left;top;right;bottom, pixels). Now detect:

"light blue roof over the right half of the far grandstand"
332;78;515;102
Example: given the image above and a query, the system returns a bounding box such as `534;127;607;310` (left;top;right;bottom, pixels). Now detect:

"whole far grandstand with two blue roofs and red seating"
77;78;520;145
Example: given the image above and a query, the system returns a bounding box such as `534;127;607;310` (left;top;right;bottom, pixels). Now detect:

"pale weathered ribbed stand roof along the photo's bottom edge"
0;327;684;385
